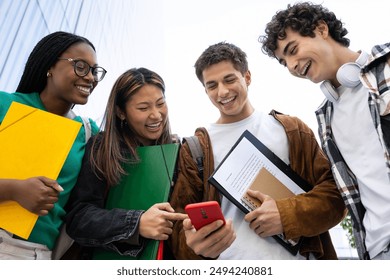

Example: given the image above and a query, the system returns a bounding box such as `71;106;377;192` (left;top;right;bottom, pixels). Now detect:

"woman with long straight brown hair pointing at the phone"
66;68;187;256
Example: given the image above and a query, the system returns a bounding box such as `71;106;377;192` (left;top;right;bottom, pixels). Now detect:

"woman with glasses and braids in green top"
0;31;106;259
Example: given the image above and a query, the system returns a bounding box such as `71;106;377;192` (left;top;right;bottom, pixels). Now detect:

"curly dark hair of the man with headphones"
259;2;349;58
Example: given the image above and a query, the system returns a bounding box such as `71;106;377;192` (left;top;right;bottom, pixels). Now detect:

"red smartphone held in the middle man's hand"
184;201;225;230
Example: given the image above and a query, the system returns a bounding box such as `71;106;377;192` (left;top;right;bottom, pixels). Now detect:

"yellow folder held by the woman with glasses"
0;102;81;239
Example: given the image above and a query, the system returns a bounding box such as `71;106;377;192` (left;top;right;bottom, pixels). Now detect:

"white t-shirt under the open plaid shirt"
331;84;390;258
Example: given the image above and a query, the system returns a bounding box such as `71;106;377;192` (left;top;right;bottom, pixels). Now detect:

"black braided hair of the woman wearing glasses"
16;31;96;93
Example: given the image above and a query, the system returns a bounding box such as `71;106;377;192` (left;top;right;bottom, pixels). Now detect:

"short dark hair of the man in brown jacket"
195;42;248;84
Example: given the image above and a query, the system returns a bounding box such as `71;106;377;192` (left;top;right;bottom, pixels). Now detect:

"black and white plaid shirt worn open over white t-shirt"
316;43;390;259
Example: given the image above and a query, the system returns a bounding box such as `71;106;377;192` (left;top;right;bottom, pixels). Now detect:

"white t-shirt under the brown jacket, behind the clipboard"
208;111;304;260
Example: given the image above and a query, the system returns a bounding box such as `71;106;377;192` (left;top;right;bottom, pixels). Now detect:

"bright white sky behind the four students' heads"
76;0;390;137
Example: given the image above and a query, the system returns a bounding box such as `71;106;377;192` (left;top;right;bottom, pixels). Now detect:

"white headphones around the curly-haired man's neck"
320;51;368;102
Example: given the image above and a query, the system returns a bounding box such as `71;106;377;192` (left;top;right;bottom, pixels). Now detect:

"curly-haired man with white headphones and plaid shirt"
259;2;390;259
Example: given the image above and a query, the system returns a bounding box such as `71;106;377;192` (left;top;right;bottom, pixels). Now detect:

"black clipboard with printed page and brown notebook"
208;130;313;255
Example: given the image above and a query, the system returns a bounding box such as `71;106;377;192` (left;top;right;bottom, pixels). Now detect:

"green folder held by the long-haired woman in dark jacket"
93;143;180;260
